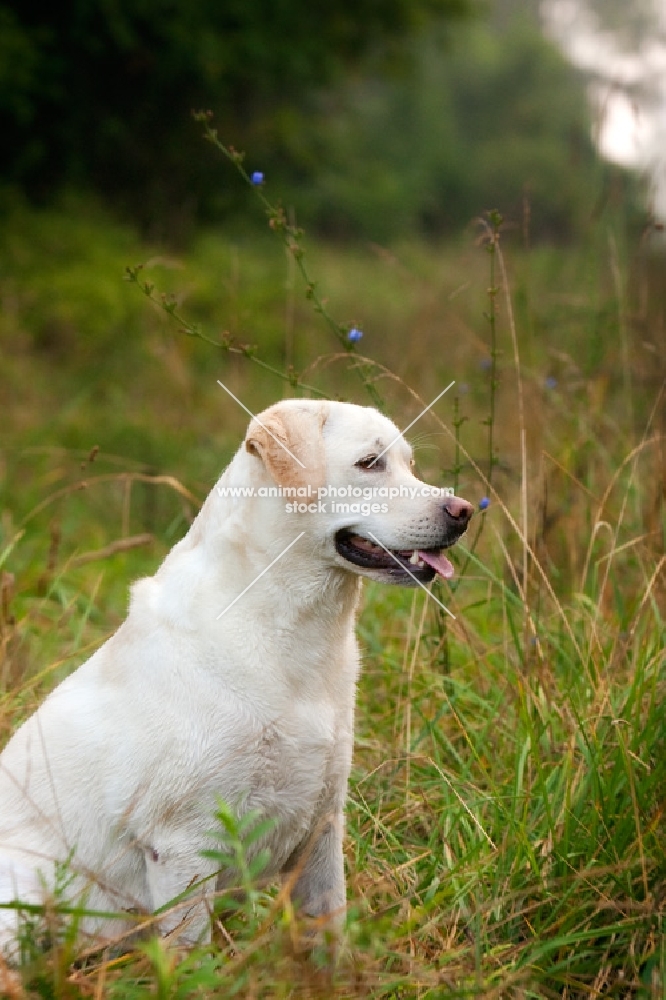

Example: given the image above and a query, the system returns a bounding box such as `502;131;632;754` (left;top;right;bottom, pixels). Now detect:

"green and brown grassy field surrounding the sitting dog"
0;193;666;1000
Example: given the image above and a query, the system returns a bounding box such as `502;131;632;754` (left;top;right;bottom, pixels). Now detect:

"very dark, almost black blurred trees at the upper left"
0;0;474;232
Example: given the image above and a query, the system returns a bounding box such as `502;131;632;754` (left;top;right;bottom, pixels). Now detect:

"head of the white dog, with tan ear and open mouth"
245;400;473;586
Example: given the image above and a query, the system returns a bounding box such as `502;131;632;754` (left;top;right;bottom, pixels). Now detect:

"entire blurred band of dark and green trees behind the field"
0;0;644;242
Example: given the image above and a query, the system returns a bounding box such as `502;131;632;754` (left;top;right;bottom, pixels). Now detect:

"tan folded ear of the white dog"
245;403;328;489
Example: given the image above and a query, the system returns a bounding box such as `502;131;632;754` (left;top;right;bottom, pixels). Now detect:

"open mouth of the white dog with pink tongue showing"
335;528;454;583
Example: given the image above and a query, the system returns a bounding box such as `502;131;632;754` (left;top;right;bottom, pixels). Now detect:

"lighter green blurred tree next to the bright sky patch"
286;0;640;240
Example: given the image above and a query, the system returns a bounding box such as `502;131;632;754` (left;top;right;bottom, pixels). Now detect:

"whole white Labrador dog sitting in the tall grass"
0;400;471;950
